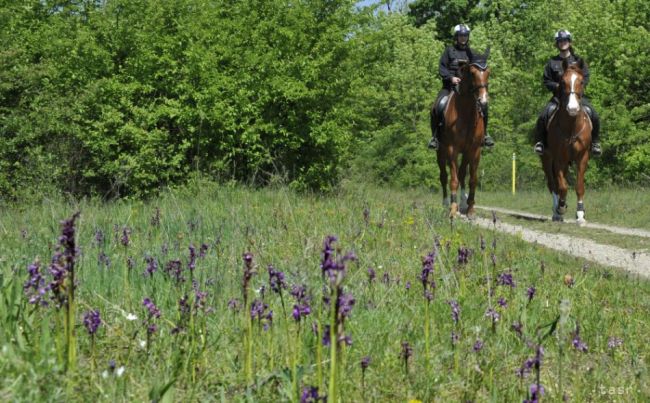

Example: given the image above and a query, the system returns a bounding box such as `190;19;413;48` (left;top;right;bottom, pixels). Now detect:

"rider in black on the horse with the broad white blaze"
534;29;602;156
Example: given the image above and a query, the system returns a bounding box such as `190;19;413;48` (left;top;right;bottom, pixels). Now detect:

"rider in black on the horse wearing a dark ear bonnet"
429;24;494;150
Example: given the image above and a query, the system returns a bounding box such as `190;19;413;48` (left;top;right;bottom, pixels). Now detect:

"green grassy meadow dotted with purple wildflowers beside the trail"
0;183;650;402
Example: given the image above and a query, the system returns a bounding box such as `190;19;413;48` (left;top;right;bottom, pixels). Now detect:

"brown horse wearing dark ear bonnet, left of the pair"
431;49;490;218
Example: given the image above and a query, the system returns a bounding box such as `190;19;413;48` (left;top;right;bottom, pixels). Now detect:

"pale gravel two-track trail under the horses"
464;206;650;278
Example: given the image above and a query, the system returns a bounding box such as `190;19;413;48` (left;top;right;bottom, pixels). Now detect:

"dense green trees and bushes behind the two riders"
0;0;650;199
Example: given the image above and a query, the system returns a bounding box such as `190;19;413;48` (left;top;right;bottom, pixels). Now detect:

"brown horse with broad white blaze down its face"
541;59;592;225
